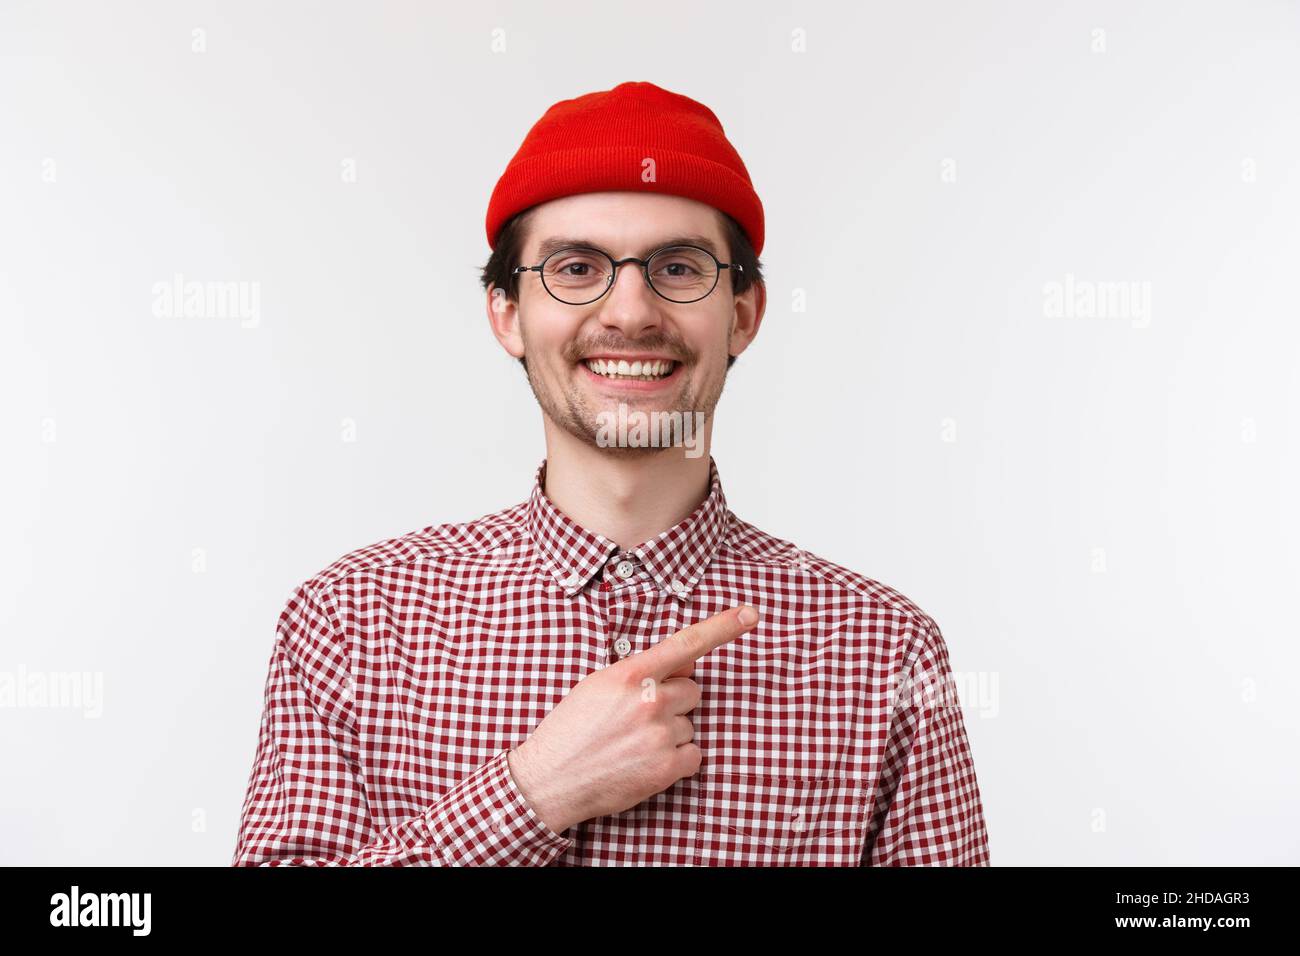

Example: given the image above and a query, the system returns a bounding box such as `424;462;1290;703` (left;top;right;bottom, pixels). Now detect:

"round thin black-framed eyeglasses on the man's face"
512;246;745;306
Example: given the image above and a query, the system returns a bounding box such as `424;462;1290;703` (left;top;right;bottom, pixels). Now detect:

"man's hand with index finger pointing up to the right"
508;606;758;834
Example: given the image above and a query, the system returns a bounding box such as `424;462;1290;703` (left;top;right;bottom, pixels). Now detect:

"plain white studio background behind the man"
0;0;1300;865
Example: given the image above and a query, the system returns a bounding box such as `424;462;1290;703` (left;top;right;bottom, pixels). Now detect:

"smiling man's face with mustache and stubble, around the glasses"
489;193;762;454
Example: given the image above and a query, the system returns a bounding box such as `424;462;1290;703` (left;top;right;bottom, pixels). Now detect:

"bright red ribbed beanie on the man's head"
488;83;763;255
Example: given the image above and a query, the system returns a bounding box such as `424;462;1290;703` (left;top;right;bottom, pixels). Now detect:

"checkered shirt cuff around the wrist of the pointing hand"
426;749;573;866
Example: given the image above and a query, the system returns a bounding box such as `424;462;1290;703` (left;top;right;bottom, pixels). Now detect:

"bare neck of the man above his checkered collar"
543;415;714;550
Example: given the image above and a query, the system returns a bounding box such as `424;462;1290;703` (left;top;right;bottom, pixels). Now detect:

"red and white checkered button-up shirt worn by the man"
233;458;989;866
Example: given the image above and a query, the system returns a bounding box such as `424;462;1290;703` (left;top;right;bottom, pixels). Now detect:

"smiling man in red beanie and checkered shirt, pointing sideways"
234;83;988;866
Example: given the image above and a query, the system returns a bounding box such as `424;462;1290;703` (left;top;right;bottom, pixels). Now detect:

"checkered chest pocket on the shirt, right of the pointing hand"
694;774;870;866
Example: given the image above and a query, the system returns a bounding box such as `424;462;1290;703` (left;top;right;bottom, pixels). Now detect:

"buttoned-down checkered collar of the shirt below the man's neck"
525;455;729;598
